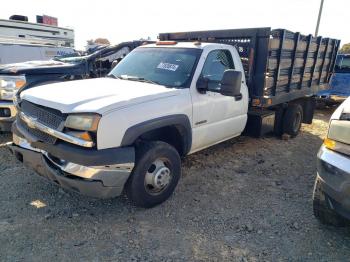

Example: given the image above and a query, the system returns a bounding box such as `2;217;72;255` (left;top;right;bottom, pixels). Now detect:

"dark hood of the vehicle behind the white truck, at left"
0;60;82;75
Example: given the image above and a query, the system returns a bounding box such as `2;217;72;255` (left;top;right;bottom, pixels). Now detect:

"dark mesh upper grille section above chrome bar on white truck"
21;100;65;131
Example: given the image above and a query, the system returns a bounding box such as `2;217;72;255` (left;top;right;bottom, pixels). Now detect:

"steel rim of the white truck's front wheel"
144;158;172;195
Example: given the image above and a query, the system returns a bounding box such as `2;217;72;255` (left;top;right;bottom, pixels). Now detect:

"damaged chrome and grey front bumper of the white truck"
8;128;135;198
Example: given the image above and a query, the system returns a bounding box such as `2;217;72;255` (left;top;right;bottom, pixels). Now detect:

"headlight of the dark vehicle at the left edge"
0;75;26;100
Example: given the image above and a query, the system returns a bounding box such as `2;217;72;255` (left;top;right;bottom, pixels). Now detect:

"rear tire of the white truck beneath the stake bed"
283;104;303;137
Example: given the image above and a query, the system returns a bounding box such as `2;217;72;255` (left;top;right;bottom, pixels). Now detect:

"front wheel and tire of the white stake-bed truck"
125;141;181;208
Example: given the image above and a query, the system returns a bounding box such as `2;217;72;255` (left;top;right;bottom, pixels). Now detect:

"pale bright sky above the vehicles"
0;0;350;49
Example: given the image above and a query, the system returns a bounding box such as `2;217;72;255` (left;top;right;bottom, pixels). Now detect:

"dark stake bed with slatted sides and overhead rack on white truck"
159;27;340;107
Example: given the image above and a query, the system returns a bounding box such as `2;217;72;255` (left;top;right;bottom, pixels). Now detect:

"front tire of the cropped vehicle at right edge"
312;179;348;226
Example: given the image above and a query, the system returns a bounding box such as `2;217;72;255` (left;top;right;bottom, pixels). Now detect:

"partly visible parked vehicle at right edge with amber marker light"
313;98;350;226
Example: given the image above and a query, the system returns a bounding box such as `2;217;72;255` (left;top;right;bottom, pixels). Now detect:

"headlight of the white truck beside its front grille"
65;114;101;131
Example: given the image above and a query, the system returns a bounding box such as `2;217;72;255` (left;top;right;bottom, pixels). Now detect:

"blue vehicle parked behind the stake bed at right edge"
318;54;350;106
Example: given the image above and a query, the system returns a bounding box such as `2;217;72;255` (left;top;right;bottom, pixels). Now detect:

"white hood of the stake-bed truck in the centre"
20;78;178;115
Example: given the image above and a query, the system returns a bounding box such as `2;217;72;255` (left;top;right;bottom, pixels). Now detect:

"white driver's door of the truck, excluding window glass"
190;44;248;153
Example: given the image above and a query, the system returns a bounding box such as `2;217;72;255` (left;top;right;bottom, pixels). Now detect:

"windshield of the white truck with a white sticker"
109;47;202;88
